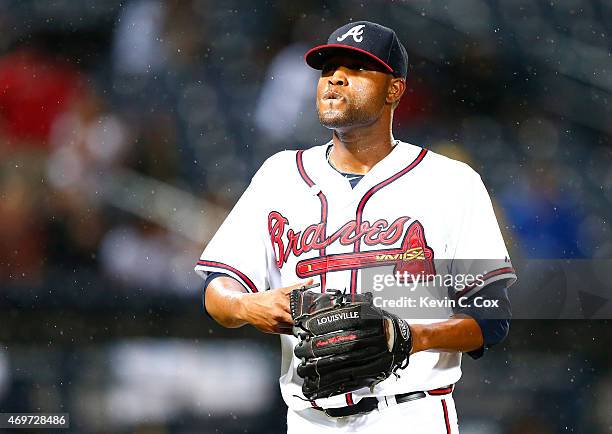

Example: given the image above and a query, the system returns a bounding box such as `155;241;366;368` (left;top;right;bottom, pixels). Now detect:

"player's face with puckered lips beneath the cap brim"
317;54;392;129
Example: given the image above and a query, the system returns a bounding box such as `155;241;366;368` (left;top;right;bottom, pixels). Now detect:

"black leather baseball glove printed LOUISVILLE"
290;288;412;399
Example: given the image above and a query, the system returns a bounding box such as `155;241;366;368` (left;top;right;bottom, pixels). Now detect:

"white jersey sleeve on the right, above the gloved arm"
450;169;516;297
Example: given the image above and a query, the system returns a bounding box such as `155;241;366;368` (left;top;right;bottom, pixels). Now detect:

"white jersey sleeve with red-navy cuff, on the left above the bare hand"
195;163;274;292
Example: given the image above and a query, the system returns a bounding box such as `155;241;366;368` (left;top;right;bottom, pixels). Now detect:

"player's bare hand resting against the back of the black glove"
241;279;313;334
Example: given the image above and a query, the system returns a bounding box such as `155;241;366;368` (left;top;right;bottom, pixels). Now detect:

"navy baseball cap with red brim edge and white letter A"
304;21;408;78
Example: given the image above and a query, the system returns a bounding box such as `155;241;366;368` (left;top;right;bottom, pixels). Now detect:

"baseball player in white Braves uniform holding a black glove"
195;21;516;434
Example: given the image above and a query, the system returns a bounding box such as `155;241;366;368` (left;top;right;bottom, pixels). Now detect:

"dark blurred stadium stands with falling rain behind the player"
0;0;612;434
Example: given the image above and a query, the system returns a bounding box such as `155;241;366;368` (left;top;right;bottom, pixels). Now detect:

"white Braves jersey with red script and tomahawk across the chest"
195;141;516;411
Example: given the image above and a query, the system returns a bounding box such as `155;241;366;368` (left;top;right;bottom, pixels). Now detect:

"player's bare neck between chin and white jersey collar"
329;128;394;175
